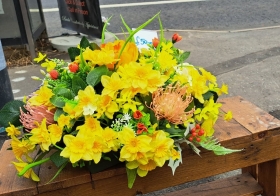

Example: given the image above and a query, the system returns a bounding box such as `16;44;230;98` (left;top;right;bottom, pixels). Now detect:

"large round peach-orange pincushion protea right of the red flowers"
150;83;194;124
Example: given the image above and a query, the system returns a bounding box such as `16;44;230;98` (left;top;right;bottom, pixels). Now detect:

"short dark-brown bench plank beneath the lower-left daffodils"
38;161;91;193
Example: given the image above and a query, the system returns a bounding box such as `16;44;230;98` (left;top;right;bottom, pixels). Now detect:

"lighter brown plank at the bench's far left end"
0;140;38;196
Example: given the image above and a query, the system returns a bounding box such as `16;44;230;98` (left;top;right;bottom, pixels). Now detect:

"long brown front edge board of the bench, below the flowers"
36;135;280;196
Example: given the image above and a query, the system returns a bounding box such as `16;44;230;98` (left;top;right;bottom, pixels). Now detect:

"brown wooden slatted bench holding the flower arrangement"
0;97;280;196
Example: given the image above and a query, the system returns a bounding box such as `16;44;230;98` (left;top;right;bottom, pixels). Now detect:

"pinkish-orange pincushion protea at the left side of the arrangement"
20;104;55;131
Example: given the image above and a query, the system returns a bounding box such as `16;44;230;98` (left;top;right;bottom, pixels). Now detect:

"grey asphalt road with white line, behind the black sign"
42;0;280;37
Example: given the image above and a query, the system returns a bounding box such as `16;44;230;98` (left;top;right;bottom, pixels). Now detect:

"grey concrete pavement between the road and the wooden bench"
2;28;280;195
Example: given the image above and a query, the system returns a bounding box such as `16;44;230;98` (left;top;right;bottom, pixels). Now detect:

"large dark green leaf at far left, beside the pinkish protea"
0;100;25;127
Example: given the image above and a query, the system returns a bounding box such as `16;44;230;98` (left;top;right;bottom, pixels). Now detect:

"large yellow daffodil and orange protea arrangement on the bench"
0;14;238;187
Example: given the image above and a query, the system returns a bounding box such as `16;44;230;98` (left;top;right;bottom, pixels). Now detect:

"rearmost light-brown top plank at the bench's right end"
220;96;280;139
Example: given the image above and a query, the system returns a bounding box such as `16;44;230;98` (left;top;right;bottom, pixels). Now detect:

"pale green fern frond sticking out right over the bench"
199;137;241;155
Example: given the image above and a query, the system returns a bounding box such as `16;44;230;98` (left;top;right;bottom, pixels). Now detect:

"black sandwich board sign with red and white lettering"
57;0;103;38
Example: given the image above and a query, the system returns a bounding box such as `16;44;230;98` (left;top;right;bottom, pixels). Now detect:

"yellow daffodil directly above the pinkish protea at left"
28;83;55;110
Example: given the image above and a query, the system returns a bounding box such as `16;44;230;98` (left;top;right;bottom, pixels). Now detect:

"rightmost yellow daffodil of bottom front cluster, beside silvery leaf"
150;130;174;167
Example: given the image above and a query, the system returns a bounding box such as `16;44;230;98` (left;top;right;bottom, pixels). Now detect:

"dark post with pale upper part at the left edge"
0;40;14;110
